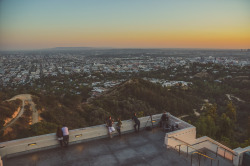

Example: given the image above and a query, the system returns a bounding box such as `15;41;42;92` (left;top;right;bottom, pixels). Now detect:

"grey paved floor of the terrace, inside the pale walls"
3;128;190;166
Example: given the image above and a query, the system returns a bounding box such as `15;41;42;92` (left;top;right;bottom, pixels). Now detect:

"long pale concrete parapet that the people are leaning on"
0;114;161;157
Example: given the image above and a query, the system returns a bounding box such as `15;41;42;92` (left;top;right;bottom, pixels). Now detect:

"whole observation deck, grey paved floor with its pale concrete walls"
0;114;250;166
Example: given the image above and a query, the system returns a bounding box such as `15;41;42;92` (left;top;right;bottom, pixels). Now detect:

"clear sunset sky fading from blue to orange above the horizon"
0;0;250;50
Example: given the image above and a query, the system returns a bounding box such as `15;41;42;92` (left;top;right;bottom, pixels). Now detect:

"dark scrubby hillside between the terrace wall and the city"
0;78;250;147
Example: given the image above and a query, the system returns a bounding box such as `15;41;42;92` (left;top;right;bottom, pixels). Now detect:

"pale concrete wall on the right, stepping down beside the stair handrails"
165;116;250;166
